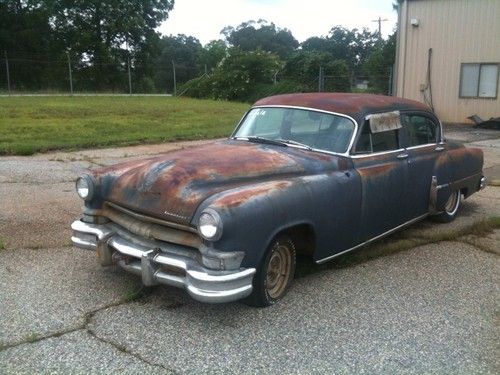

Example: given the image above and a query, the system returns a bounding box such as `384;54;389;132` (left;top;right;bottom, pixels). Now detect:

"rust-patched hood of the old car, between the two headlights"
94;140;338;224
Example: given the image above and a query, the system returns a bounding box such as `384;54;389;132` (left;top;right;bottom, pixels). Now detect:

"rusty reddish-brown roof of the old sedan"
254;92;432;124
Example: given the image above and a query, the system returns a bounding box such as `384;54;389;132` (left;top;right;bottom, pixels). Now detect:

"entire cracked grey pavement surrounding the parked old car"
0;132;500;374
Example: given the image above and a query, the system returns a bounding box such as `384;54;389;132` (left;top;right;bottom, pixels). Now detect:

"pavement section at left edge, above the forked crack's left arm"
0;247;141;348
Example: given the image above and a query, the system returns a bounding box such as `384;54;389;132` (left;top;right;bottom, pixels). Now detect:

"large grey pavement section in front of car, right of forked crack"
89;243;500;374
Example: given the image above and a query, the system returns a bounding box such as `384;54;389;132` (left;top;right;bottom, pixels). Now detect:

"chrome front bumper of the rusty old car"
71;220;255;303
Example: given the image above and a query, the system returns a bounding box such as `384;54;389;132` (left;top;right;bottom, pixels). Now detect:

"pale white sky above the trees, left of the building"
158;0;397;45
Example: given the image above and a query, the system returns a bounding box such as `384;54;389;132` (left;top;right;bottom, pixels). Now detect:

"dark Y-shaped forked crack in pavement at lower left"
0;288;178;374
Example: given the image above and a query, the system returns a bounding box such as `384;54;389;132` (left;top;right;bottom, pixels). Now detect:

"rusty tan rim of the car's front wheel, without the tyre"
266;244;292;298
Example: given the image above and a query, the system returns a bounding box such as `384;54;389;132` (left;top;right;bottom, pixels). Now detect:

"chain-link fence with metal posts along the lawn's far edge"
0;53;392;96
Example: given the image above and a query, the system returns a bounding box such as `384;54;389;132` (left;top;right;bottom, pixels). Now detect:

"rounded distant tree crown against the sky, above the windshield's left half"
221;20;299;59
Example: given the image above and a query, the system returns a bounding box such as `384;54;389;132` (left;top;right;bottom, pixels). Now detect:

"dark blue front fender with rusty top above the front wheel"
193;172;360;267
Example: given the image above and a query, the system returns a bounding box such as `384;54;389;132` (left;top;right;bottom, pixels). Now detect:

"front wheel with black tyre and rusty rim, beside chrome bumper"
245;236;295;307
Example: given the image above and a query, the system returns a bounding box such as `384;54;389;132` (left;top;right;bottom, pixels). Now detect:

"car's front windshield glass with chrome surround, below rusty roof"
233;107;355;153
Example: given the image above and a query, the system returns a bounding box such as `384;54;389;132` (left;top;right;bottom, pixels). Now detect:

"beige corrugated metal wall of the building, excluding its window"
396;0;500;122
